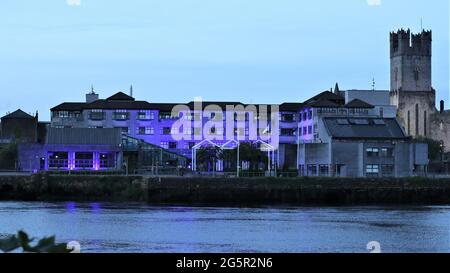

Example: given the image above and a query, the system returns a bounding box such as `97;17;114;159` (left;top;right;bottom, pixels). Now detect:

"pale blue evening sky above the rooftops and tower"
0;0;450;120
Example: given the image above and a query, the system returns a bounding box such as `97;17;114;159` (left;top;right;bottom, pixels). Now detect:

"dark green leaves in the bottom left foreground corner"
0;231;72;253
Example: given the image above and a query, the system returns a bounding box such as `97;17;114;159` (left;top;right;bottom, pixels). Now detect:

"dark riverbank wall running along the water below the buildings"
0;174;450;206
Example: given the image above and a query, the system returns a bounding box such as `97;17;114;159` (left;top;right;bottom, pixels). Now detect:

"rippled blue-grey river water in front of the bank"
0;202;450;253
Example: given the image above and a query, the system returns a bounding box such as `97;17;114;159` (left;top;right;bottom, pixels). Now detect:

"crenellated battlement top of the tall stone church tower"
390;29;432;57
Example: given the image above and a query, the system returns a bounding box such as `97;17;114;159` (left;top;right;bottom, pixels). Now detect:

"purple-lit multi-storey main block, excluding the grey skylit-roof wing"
46;87;398;168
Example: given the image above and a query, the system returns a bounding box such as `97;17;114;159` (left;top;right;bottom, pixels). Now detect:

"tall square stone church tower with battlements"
390;29;436;137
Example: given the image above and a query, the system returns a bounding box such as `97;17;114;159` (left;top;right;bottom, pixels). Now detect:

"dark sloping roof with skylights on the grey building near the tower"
324;117;409;140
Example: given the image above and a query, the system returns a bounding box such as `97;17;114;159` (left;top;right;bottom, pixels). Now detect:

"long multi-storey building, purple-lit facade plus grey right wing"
45;84;428;177
